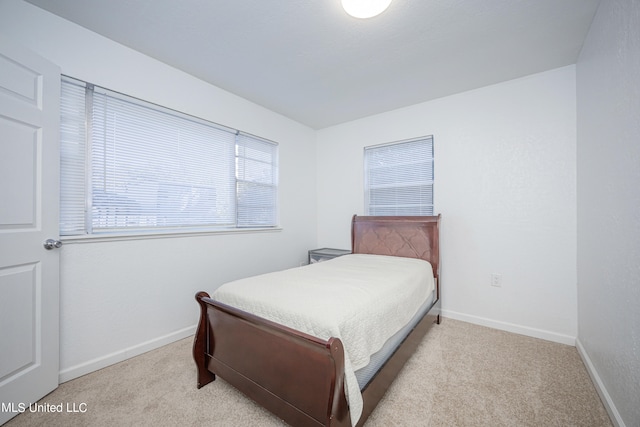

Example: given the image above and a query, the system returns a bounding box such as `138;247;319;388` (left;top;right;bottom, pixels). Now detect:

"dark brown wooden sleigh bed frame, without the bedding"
193;215;440;427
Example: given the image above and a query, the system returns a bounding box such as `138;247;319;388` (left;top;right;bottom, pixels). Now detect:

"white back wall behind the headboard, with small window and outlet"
317;66;577;344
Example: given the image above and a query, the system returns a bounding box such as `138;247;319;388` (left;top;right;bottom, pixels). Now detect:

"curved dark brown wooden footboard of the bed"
193;292;351;426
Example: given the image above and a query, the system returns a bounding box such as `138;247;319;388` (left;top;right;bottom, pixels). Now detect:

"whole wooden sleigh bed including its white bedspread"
193;215;440;426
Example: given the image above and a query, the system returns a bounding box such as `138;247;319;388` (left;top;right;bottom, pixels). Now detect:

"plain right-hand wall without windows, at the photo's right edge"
576;0;640;426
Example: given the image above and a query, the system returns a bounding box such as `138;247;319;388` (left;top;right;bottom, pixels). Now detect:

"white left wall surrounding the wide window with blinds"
0;0;316;380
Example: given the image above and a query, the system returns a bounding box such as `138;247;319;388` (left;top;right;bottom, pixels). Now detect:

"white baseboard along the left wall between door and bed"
58;325;196;384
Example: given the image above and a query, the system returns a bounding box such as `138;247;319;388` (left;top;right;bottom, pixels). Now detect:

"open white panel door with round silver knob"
0;38;60;424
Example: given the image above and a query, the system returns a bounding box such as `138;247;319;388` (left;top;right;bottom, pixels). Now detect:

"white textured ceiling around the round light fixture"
27;0;599;129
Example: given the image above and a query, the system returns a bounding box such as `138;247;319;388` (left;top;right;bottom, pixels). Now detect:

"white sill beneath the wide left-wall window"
60;226;282;244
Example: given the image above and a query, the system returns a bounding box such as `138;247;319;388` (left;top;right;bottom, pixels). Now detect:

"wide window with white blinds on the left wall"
60;78;278;236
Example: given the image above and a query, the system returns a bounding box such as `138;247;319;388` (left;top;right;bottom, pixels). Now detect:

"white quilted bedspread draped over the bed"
212;254;434;426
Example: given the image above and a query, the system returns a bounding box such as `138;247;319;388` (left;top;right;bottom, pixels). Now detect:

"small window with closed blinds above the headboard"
364;136;433;216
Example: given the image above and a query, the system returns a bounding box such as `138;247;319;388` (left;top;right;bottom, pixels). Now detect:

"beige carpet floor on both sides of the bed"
6;319;611;427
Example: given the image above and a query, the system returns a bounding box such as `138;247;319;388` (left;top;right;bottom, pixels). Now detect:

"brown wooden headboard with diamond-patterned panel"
351;215;440;278
